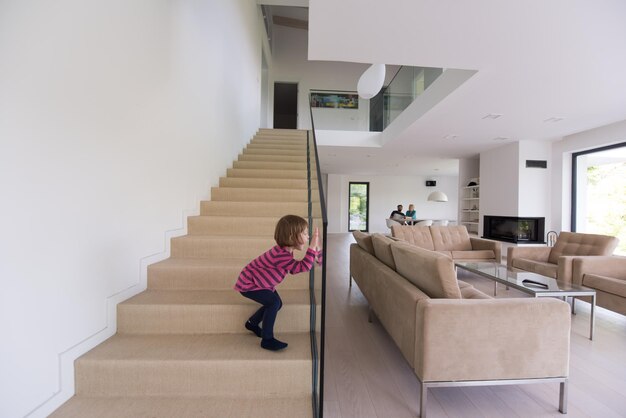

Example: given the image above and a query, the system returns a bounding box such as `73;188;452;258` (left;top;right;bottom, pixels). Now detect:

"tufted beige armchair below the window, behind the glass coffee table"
506;232;619;283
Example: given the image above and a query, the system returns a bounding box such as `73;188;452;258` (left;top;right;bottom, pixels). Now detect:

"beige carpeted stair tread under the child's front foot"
77;334;311;363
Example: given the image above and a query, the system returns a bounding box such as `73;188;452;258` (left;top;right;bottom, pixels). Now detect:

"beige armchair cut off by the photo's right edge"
572;256;626;315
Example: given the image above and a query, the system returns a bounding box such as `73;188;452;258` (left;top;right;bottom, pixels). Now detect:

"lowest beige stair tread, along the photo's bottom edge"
50;393;313;418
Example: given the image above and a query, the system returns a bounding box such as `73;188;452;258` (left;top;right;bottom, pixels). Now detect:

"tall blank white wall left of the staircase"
0;0;261;417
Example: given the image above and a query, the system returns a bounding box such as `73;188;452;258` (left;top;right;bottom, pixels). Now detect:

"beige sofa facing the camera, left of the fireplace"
391;225;502;263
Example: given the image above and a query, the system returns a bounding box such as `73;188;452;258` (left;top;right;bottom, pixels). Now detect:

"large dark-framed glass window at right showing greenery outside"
572;143;626;255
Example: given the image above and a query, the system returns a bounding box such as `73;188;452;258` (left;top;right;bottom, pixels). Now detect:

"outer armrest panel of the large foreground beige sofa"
414;298;571;382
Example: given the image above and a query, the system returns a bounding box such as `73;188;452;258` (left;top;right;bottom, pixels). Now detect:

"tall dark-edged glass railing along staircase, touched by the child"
307;122;328;418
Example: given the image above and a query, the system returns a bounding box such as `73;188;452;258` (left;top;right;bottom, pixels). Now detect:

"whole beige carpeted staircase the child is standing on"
51;130;321;418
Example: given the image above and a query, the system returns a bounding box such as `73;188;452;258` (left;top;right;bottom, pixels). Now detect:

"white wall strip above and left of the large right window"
546;120;626;231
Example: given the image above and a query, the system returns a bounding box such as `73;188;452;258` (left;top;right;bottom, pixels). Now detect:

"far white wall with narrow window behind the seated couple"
327;174;458;233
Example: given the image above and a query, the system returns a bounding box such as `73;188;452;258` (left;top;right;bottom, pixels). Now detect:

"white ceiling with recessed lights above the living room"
300;0;626;176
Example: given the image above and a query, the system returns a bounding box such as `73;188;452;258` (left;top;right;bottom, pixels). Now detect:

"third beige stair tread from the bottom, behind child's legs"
120;290;310;306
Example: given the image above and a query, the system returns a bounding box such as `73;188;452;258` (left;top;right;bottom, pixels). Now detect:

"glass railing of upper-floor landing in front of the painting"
310;66;443;132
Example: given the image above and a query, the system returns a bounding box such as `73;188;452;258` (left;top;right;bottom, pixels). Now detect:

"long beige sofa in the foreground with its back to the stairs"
350;232;570;417
